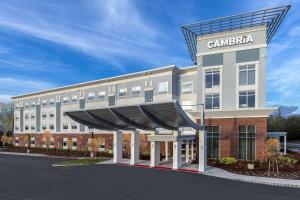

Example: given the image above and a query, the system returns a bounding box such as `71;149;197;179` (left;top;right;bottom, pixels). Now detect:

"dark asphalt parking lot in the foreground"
0;155;300;200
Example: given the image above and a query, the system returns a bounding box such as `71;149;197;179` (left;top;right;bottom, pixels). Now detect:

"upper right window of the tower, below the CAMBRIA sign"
239;64;255;85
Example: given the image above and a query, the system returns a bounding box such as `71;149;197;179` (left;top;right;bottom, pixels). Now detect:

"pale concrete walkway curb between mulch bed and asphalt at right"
203;167;300;188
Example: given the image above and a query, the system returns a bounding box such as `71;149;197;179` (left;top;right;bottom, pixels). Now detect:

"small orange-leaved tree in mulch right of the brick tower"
264;138;280;174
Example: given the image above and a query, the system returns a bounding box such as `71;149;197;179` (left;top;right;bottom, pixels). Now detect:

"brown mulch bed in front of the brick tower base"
208;153;300;180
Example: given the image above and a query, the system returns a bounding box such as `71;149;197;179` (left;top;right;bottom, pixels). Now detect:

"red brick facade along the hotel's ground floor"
15;118;267;160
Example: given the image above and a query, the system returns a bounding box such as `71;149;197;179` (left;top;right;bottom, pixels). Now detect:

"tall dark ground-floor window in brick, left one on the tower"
205;126;220;159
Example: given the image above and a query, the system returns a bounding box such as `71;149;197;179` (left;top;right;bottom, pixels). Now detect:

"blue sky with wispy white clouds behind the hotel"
0;0;300;112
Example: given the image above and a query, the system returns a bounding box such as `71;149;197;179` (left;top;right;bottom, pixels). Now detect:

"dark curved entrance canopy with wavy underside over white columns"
65;101;201;131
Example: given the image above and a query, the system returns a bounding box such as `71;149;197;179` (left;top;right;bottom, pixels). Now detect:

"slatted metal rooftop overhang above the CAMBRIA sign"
181;5;291;63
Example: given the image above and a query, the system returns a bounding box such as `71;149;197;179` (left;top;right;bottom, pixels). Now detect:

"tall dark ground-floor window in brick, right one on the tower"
239;125;256;161
